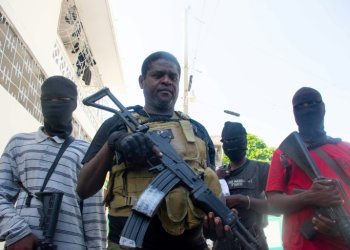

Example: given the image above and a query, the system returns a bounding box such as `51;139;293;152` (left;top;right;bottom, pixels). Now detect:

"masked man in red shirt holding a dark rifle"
266;87;350;250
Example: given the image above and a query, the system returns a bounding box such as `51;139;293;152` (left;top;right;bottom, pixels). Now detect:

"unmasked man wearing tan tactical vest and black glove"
77;51;221;250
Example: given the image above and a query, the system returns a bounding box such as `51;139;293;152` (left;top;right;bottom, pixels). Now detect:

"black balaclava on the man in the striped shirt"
41;76;78;139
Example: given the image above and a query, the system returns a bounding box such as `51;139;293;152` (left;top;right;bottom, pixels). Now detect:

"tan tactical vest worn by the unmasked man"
107;112;221;235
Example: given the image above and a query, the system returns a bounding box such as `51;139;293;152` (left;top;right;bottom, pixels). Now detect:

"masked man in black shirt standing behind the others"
213;122;269;250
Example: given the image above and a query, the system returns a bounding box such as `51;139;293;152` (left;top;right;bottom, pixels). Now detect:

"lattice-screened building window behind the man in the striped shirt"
0;9;91;140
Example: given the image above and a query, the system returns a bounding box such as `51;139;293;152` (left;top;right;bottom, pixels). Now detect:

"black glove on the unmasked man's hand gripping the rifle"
107;131;154;163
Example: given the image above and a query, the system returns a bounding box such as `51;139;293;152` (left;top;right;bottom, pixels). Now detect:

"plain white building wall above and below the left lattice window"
0;0;61;153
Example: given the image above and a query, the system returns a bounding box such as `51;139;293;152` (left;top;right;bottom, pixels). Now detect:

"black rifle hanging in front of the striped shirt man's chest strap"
35;192;63;250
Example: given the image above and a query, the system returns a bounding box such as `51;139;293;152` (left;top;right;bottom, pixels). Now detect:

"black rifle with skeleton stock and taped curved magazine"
83;88;258;250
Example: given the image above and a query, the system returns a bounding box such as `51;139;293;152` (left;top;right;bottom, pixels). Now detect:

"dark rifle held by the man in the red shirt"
279;132;350;247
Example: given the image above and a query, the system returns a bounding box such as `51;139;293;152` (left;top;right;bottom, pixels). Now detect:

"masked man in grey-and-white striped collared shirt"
0;76;106;250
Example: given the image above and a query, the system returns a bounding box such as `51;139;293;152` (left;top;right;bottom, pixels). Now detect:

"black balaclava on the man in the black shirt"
221;122;247;163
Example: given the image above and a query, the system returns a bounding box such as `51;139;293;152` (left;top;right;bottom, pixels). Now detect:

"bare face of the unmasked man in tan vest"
139;59;180;112
